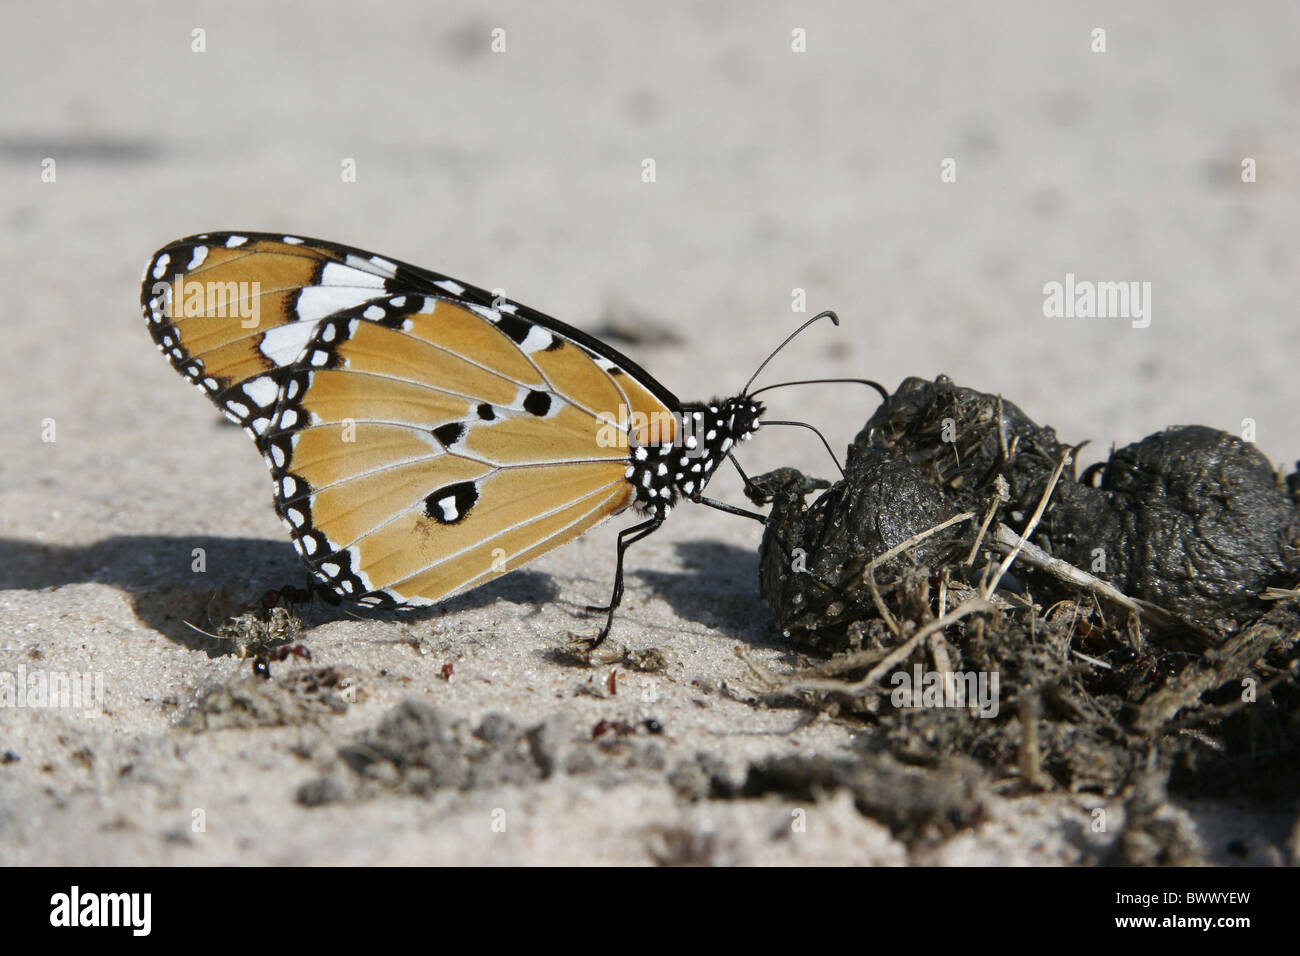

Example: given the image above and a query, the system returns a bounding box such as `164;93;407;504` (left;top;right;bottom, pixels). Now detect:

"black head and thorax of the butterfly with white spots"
627;395;763;518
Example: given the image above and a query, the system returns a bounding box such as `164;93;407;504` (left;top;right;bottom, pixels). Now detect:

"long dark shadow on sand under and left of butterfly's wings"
0;535;559;657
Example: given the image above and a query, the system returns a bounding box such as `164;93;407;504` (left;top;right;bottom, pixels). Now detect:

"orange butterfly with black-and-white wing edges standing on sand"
140;232;837;646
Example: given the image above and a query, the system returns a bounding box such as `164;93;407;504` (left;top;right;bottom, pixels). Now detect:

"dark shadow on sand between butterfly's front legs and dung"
629;541;788;649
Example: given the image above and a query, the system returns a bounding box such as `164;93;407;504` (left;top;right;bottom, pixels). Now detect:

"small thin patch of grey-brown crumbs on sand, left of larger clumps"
181;667;360;731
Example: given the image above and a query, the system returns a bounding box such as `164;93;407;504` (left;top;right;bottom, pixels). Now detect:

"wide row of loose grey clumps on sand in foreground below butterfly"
298;697;664;805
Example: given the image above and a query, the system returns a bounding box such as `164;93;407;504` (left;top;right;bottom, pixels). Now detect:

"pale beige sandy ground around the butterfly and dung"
0;0;1300;864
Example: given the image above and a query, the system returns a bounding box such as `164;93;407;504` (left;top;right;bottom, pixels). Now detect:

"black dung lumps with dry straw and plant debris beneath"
741;377;1300;806
